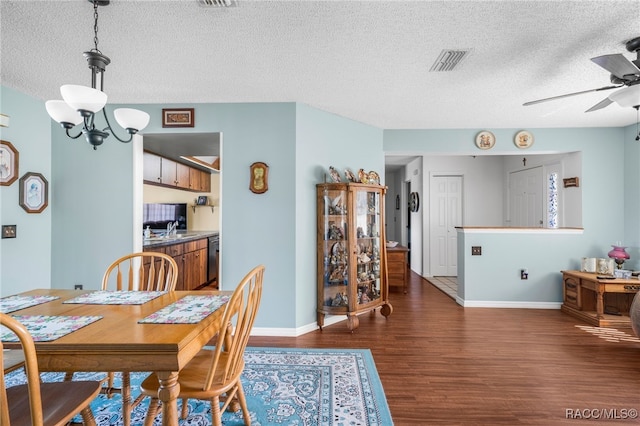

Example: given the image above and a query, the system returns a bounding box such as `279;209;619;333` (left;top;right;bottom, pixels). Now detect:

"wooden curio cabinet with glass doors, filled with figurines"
316;182;393;331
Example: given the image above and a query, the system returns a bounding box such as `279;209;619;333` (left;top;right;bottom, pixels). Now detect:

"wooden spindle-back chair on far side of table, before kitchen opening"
65;251;178;426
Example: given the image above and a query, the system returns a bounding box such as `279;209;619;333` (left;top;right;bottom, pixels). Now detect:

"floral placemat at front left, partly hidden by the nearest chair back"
0;315;102;342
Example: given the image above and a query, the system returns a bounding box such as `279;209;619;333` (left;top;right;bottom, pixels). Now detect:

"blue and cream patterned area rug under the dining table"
7;347;393;426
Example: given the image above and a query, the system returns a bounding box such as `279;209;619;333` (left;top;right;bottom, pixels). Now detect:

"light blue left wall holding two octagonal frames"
0;86;51;296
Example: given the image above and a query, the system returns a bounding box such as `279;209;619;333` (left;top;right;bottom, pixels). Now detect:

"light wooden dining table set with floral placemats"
3;289;232;425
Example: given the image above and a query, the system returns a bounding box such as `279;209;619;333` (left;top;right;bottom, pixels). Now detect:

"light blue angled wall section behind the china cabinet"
295;104;384;327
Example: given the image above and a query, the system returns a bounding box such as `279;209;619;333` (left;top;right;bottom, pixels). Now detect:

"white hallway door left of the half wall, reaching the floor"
429;176;462;276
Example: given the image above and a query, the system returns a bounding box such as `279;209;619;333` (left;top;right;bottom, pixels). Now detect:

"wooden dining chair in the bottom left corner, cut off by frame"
0;313;102;426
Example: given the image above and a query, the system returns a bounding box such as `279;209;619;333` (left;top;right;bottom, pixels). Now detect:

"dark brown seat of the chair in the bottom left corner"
7;381;102;426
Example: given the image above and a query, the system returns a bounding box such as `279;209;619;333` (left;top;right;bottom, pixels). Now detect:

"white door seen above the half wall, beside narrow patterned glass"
509;166;544;228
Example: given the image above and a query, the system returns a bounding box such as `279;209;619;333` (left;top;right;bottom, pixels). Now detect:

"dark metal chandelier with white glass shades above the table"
45;0;149;149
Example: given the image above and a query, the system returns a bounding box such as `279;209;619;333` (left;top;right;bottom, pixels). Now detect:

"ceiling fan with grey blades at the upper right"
522;37;640;112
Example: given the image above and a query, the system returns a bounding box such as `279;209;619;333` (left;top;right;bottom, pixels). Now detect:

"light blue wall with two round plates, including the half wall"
384;128;638;304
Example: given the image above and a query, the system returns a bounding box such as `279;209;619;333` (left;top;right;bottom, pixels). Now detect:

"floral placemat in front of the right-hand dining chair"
138;295;229;324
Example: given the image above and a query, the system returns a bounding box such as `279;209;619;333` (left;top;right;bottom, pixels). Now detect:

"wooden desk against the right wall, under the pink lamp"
561;271;640;328
